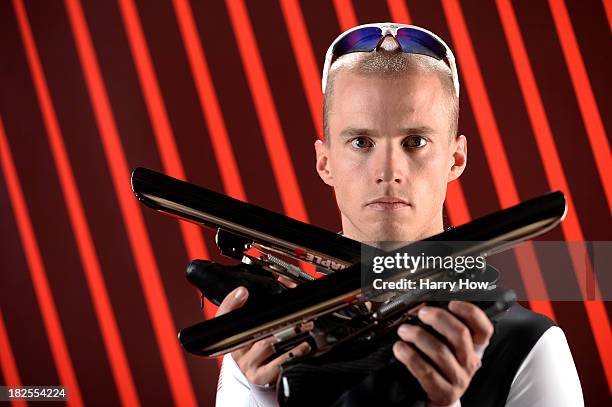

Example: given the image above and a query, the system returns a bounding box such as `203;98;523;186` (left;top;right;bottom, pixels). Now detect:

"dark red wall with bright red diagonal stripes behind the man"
0;0;612;406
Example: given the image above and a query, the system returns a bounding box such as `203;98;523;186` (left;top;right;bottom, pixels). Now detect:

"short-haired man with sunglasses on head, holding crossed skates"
217;24;583;406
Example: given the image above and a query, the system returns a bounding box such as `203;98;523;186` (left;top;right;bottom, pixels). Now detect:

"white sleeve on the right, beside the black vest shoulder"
506;326;584;407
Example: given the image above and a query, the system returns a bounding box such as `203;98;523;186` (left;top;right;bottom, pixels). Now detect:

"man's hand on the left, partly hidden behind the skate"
216;287;310;385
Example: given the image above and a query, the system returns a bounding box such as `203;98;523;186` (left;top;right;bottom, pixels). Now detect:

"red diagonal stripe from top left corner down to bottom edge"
15;1;140;406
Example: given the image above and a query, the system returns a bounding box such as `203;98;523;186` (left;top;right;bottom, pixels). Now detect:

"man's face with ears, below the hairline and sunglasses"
315;70;466;242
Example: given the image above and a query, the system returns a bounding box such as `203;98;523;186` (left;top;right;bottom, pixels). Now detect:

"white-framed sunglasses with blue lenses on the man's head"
322;23;459;96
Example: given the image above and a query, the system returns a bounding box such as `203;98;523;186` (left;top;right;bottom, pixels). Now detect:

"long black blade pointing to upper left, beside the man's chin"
132;168;361;266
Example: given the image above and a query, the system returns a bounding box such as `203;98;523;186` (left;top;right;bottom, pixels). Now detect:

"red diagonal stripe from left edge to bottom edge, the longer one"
0;112;83;407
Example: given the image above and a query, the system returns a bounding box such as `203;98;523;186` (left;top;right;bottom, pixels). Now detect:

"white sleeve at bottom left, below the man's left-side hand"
216;353;278;407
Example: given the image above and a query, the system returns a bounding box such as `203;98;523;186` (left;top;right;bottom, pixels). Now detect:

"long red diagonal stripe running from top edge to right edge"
548;0;612;214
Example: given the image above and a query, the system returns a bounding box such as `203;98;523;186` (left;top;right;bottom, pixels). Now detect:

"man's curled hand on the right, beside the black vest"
393;301;493;406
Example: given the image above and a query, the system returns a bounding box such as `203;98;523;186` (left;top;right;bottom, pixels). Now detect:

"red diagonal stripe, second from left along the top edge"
66;0;197;406
